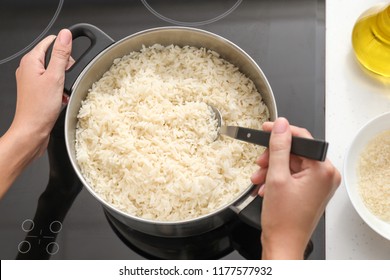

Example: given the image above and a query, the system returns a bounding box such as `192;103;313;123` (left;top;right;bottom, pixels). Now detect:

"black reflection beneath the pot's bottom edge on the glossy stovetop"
105;211;313;260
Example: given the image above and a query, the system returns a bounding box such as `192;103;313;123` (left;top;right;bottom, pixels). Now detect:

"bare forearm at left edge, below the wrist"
0;126;45;198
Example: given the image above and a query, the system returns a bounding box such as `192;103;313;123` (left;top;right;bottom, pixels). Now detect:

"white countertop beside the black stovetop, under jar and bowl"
326;0;390;260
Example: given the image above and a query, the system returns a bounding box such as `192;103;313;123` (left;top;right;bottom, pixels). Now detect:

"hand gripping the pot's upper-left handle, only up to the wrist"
11;29;73;155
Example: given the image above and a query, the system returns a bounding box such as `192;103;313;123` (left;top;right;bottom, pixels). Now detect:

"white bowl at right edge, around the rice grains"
344;112;390;240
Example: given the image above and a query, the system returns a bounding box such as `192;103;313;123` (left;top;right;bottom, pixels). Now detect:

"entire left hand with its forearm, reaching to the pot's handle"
0;29;73;198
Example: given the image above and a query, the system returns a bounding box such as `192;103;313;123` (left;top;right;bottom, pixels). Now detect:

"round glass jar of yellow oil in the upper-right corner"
352;4;390;77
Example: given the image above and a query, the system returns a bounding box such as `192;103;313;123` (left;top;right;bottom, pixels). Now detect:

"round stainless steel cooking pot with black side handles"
59;23;277;237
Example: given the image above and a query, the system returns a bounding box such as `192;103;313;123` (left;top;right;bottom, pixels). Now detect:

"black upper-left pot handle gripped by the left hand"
45;23;115;94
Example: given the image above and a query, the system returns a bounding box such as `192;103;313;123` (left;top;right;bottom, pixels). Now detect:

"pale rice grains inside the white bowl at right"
358;130;390;222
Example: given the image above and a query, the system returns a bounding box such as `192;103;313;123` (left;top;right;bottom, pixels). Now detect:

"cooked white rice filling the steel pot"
76;45;269;221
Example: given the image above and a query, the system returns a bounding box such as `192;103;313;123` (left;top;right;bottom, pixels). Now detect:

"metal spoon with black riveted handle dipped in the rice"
208;104;329;161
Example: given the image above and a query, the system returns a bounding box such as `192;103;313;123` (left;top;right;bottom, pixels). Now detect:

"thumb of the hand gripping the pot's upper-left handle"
47;29;72;77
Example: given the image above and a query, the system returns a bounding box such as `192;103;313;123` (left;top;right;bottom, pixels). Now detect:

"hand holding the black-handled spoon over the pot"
251;118;341;259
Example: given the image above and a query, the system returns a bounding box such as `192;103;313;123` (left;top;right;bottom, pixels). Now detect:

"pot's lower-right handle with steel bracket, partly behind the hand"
230;187;263;230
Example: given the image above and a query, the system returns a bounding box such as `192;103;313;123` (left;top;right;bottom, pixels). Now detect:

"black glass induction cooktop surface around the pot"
0;0;325;259
